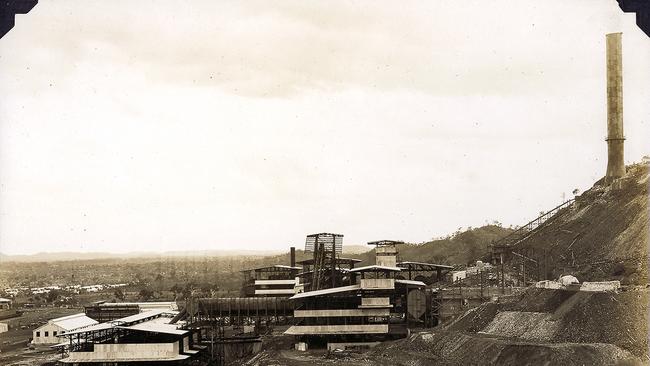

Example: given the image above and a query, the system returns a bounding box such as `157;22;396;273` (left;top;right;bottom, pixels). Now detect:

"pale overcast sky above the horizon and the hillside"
0;0;650;254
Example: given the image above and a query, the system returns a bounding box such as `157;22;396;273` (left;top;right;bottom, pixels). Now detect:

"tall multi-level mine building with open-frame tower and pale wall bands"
285;233;451;349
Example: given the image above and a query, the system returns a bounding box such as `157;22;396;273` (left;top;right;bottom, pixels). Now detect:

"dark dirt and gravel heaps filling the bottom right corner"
366;288;648;365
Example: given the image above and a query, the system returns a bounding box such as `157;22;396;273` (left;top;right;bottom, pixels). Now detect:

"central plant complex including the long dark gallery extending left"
110;233;452;361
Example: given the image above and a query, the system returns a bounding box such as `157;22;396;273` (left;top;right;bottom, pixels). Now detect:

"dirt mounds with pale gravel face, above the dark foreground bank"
447;288;649;356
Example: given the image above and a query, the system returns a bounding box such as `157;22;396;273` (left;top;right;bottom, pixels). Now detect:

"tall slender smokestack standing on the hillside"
605;33;625;183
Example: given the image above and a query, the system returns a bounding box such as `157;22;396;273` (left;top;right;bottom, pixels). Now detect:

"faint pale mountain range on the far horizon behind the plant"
0;245;370;262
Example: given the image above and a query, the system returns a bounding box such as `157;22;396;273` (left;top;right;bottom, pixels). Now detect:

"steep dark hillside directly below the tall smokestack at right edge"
514;164;649;284
